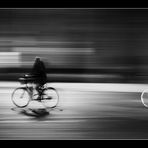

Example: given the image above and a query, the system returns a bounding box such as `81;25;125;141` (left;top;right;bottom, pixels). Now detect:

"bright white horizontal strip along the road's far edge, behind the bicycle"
0;82;148;92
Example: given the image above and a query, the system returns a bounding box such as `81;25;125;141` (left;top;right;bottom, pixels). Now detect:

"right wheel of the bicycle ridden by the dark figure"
42;87;59;108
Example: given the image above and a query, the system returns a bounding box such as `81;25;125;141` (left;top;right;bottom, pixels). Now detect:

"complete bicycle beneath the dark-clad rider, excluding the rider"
11;75;59;108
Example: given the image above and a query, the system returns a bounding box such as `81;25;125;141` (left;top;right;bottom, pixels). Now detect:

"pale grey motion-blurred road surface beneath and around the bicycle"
0;82;148;140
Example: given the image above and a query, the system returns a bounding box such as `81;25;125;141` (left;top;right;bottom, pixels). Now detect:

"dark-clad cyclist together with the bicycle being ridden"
11;57;59;107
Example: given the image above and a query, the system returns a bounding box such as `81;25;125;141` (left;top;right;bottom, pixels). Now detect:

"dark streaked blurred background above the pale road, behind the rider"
0;9;148;83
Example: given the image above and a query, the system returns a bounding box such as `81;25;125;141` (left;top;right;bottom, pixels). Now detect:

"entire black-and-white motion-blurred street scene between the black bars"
0;8;148;140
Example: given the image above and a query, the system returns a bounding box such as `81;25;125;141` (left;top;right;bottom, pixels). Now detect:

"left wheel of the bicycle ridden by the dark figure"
11;87;30;108
